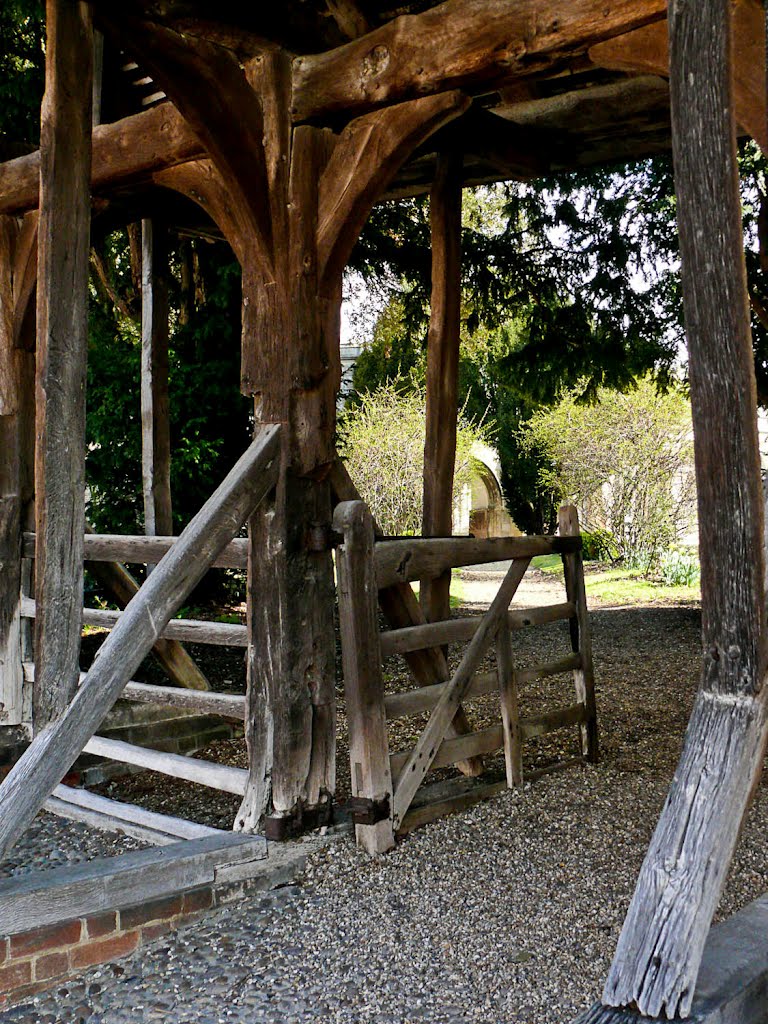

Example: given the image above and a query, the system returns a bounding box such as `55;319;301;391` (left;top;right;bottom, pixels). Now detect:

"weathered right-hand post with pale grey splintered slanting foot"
603;0;766;1018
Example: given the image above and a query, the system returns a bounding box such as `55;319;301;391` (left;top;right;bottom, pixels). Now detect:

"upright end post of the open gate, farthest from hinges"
557;505;599;764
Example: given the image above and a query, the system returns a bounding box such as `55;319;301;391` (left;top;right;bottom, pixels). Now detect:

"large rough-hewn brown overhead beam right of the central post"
292;0;667;122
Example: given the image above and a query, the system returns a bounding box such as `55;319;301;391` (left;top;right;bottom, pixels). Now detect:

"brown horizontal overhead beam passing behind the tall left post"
0;103;204;213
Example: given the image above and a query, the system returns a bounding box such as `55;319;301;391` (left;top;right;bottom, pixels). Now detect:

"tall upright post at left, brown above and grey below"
34;0;93;729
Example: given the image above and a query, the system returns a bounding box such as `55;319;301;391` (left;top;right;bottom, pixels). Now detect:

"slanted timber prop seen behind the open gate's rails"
329;459;482;776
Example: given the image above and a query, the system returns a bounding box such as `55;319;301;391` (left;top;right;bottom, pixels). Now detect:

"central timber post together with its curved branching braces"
94;8;470;836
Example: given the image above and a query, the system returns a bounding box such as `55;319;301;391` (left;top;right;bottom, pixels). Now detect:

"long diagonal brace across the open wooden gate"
393;557;530;829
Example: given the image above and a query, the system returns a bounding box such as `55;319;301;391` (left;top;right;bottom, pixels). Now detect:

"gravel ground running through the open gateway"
2;593;768;1024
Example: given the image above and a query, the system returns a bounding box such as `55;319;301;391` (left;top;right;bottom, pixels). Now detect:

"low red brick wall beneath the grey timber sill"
0;886;214;1009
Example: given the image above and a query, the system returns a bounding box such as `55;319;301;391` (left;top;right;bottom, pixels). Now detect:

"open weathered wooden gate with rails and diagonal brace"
334;501;598;853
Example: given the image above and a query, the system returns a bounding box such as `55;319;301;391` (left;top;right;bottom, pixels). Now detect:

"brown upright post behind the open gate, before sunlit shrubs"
420;153;463;623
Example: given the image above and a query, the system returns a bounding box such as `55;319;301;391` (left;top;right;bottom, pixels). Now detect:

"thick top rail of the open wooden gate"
376;537;582;590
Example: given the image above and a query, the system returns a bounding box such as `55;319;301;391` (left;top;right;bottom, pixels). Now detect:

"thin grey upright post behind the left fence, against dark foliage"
141;219;173;537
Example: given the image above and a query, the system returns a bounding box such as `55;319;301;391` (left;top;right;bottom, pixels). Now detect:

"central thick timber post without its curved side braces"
237;54;341;838
